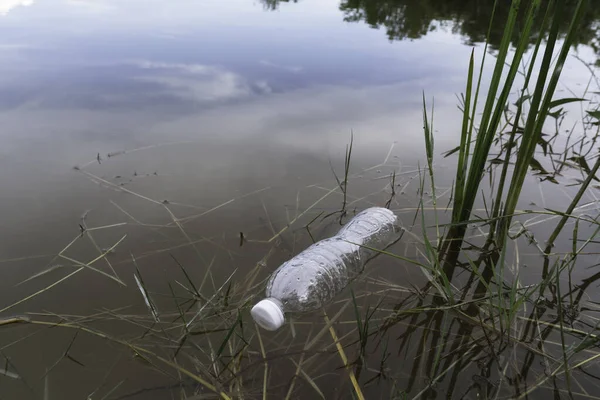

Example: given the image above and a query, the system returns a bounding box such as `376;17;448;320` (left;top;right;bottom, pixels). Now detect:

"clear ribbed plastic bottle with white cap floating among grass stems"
251;207;400;331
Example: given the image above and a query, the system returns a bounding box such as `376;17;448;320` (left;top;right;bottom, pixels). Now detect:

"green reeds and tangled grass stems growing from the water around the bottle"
0;0;600;399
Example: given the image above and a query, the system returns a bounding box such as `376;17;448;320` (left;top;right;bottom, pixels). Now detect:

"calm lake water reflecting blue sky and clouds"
0;0;600;399
